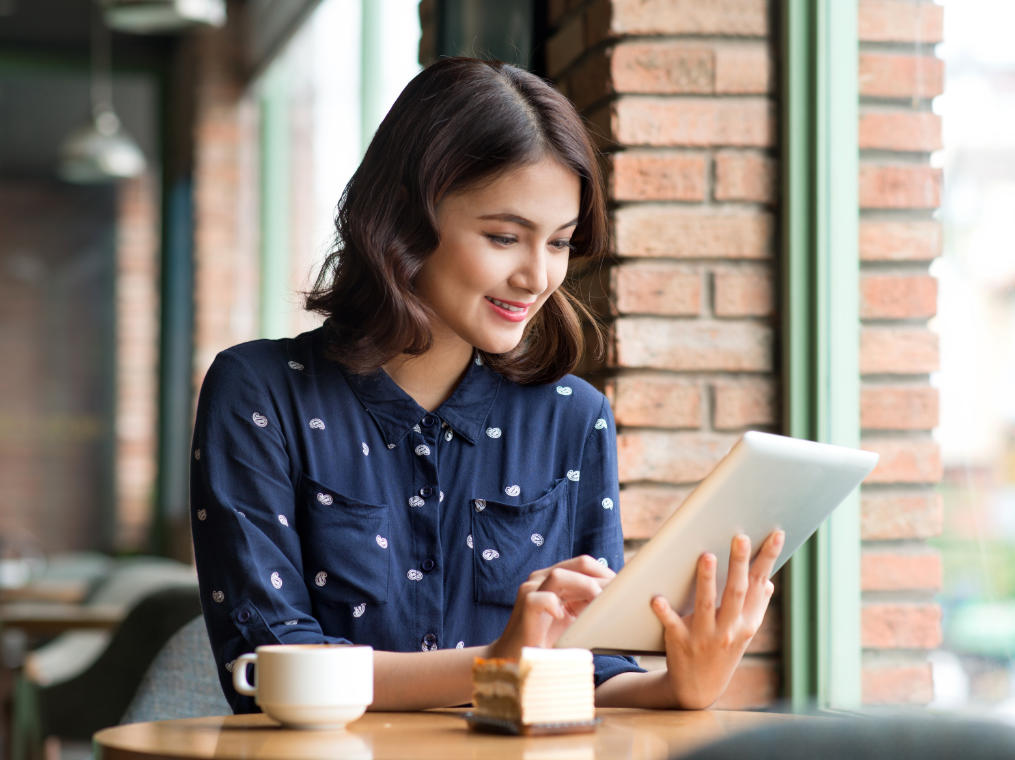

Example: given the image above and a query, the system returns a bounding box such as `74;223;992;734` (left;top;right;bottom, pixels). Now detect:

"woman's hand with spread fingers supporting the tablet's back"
652;531;786;709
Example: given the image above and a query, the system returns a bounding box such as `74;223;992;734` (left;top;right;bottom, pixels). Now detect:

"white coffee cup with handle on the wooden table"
232;644;374;729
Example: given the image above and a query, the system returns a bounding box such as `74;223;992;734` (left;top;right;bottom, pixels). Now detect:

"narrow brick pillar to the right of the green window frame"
859;0;944;703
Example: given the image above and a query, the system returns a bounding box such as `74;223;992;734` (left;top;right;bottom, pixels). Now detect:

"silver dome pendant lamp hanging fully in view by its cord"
58;1;145;184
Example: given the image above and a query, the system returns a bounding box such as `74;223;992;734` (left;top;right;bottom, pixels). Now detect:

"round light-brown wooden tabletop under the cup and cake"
93;708;807;760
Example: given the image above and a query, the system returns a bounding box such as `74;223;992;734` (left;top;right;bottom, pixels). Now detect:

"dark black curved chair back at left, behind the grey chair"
11;580;201;760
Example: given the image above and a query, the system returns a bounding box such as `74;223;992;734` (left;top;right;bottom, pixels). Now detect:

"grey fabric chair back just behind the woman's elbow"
120;616;232;723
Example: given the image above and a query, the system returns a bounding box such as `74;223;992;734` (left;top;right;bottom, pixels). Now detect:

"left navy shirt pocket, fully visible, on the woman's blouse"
298;475;391;605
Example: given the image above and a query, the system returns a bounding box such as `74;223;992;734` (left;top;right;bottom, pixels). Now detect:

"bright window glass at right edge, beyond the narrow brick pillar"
932;0;1015;716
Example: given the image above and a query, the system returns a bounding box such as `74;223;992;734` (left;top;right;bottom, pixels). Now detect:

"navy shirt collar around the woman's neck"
342;354;503;445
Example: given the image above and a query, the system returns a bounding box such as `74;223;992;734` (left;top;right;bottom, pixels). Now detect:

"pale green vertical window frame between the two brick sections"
781;0;862;709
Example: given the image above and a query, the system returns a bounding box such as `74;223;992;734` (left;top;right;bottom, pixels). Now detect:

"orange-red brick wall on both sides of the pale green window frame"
546;0;943;707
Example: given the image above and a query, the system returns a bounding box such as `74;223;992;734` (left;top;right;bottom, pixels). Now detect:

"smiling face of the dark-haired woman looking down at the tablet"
416;157;582;354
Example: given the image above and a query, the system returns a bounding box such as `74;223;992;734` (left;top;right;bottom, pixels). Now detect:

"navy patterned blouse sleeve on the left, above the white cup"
191;352;348;712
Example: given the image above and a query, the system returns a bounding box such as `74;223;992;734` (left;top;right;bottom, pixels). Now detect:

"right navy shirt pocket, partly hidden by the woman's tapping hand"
472;478;571;606
